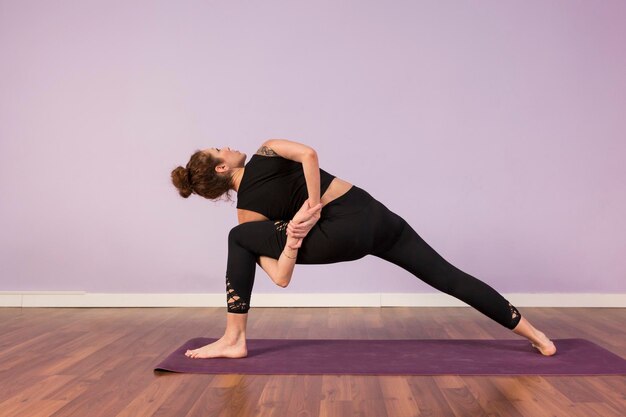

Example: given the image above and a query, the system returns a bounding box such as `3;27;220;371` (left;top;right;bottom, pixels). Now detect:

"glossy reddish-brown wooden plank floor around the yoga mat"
0;307;626;417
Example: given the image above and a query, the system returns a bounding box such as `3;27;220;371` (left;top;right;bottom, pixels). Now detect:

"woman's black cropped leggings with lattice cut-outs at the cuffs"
226;185;521;329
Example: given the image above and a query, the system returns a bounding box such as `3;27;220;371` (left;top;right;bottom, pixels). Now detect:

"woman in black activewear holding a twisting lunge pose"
172;139;556;358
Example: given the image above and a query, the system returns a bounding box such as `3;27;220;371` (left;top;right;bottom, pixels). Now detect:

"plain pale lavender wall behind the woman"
0;0;626;293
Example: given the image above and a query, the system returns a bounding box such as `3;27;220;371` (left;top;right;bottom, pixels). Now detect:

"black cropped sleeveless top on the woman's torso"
237;154;335;220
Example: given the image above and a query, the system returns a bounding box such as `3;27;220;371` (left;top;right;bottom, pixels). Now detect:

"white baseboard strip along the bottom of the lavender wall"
0;291;626;308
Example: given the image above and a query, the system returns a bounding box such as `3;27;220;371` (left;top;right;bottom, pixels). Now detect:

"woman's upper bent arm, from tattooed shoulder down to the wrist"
262;139;321;207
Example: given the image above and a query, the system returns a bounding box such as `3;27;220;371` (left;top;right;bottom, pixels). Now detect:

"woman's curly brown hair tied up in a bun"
172;150;232;201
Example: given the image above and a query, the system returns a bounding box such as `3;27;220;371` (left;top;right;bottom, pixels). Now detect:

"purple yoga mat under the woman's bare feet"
155;337;626;375
